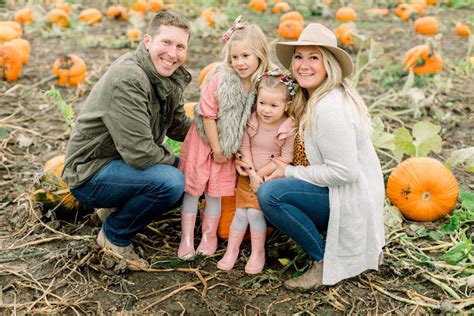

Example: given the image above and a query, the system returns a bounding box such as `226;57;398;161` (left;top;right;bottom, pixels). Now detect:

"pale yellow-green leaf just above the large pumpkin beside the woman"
413;121;441;157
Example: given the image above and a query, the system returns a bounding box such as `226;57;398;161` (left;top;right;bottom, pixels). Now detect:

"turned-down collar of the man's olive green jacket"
135;42;191;97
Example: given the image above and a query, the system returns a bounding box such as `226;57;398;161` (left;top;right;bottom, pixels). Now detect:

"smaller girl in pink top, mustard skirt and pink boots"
217;69;296;274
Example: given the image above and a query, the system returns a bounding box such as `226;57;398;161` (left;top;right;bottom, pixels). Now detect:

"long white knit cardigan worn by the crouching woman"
285;89;385;285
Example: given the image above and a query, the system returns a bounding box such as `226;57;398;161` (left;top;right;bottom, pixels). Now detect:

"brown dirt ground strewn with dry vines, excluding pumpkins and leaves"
0;2;474;315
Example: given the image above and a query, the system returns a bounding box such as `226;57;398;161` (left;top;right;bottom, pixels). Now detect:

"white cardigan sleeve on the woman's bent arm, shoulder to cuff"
285;93;358;187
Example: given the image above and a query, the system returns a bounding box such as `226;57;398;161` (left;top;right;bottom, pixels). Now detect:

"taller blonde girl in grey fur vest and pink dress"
178;17;269;260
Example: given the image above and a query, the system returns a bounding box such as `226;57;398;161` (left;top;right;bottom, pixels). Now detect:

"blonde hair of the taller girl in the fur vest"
222;22;273;85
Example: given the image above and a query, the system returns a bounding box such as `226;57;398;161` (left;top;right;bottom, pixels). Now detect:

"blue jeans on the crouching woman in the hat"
257;178;329;261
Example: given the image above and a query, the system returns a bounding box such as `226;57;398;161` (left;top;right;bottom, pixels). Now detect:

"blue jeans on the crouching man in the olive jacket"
71;159;184;247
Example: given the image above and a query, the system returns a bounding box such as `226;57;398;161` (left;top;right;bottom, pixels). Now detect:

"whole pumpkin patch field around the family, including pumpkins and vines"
0;0;474;315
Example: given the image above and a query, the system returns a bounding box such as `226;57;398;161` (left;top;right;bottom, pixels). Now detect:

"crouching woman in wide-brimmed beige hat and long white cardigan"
257;23;385;290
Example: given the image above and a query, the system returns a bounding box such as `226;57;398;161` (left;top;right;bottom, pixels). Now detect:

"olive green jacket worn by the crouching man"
62;43;191;188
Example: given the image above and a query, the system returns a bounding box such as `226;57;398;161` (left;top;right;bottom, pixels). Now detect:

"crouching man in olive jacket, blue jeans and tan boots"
63;11;191;269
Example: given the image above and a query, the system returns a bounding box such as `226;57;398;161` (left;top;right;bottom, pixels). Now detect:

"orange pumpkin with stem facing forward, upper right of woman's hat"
402;45;443;75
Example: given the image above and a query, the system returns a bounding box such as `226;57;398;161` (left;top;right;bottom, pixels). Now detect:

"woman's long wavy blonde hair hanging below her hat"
288;46;370;135
